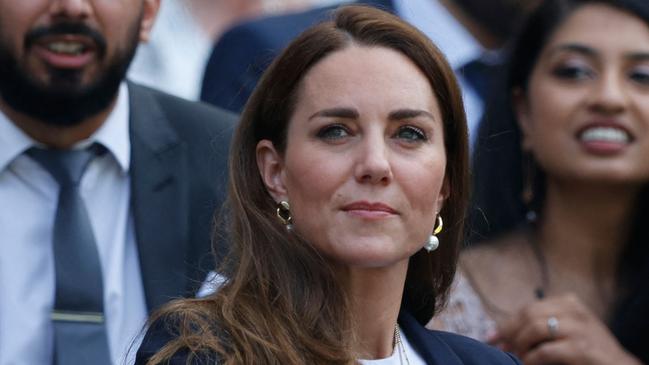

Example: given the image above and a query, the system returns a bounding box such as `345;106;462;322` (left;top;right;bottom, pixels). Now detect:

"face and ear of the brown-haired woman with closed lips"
257;45;446;267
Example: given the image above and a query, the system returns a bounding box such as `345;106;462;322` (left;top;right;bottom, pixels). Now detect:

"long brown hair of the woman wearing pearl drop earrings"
149;6;468;365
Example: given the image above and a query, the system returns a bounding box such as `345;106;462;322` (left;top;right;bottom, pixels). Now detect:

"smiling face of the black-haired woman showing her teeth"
517;4;649;184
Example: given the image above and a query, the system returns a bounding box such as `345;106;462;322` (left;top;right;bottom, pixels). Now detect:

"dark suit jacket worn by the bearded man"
128;83;236;311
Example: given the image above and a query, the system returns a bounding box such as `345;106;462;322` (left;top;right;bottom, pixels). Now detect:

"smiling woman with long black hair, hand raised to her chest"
431;0;649;365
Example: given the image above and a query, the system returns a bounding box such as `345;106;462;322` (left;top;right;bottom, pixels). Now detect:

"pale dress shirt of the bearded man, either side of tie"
0;84;147;365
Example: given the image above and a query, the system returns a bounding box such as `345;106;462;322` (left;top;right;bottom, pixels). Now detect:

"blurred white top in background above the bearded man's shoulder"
128;0;212;100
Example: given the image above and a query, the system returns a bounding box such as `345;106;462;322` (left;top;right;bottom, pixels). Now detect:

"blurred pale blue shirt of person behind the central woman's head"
394;0;487;144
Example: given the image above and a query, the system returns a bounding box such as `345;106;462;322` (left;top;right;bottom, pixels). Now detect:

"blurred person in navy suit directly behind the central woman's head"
201;0;537;141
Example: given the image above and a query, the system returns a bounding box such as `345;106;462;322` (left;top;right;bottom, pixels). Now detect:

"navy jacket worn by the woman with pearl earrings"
135;312;520;365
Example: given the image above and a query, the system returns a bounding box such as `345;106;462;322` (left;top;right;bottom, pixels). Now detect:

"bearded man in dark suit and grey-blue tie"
0;0;235;365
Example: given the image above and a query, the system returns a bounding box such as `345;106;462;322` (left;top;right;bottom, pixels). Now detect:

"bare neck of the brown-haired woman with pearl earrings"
345;260;408;359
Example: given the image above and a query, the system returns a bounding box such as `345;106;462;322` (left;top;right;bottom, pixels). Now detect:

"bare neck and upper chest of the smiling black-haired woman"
536;181;640;312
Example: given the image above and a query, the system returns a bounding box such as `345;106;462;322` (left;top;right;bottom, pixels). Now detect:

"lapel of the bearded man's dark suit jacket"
129;84;189;310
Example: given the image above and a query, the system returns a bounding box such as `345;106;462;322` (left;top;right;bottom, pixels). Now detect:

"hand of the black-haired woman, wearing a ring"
489;294;642;365
